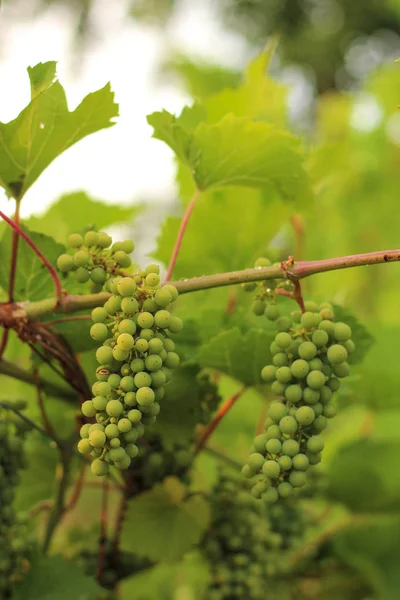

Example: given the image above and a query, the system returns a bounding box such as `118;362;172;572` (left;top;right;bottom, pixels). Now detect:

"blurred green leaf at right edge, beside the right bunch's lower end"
329;439;400;512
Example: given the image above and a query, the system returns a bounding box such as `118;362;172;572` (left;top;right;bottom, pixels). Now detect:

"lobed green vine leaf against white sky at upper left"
0;62;118;199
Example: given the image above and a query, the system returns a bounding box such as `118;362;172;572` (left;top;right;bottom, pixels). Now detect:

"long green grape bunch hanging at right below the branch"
242;302;355;503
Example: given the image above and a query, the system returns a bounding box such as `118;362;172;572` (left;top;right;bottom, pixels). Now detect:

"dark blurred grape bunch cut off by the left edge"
0;407;32;598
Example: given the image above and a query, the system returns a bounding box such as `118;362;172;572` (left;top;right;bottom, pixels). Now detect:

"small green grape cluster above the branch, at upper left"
57;231;135;291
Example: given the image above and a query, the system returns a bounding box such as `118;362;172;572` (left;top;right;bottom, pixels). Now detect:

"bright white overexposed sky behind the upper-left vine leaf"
0;0;250;216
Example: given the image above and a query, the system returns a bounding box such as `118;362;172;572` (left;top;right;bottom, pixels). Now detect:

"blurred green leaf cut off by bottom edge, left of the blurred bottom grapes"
120;555;209;600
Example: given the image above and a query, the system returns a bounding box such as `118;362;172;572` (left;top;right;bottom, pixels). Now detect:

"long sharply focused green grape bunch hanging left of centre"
78;265;182;476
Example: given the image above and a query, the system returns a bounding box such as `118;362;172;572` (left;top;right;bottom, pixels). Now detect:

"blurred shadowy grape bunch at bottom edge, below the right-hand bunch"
202;474;285;600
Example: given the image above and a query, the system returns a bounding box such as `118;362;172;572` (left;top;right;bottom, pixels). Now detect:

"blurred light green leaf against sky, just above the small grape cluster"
26;192;141;243
